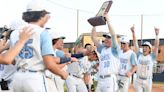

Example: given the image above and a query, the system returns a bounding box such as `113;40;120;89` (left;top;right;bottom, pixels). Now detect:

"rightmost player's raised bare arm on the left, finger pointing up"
130;25;139;53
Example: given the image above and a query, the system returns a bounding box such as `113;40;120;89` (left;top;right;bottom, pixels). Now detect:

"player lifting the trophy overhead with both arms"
92;14;120;92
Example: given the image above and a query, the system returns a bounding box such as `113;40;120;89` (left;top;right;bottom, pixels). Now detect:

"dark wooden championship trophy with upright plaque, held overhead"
88;1;113;26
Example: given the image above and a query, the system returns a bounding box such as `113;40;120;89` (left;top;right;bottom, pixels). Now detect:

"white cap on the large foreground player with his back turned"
26;0;50;13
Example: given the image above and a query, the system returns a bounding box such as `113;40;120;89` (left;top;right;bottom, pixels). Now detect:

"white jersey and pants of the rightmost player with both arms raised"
134;52;156;92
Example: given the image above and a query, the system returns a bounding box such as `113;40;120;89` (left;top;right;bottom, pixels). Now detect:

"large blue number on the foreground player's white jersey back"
19;39;33;59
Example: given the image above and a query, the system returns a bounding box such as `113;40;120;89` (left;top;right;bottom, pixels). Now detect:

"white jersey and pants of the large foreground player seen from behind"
10;24;54;92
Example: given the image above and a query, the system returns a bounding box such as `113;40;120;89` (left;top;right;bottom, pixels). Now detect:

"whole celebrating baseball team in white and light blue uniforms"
0;0;159;92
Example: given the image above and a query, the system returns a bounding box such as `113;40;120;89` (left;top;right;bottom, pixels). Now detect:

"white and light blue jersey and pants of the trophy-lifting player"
95;37;120;92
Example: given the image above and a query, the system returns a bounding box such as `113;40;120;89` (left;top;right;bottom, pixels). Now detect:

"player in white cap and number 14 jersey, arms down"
118;36;137;92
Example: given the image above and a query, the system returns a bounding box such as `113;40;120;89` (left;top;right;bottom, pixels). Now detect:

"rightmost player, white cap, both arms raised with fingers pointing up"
131;26;159;92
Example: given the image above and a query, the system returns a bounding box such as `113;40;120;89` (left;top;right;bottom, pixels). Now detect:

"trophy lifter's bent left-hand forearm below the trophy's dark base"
91;27;100;48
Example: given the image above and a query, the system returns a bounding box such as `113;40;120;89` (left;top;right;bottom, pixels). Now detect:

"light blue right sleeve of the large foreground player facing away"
40;31;54;56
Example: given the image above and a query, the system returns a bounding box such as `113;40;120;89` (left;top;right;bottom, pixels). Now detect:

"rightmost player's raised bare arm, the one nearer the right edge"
153;27;159;56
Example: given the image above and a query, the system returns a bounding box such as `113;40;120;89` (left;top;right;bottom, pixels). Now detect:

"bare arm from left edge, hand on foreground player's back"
0;27;32;64
